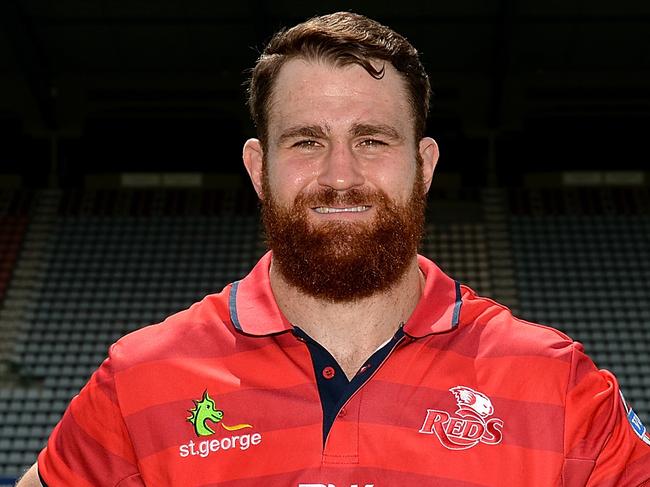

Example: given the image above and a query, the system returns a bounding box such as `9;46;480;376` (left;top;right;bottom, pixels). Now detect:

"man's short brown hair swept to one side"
248;12;431;146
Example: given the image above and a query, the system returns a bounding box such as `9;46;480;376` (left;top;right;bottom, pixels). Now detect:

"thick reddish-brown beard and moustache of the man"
262;161;426;302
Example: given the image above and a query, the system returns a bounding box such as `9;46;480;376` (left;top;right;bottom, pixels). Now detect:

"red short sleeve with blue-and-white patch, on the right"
563;343;650;487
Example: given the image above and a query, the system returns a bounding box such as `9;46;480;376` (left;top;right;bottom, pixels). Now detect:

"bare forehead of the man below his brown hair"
268;58;412;137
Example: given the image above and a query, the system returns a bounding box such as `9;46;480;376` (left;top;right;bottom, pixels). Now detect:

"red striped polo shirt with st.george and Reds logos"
38;254;650;487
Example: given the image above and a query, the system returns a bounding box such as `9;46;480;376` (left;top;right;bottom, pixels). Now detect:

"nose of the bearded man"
318;143;365;191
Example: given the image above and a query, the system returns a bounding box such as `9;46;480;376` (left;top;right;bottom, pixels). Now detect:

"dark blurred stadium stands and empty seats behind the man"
0;0;650;485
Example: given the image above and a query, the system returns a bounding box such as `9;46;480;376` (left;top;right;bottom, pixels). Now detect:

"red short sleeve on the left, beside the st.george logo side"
38;346;144;487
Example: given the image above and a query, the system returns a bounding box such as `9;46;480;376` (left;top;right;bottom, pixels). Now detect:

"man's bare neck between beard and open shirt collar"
270;256;424;378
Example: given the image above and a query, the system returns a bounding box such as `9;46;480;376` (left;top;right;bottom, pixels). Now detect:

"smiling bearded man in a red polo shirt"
19;13;650;487
